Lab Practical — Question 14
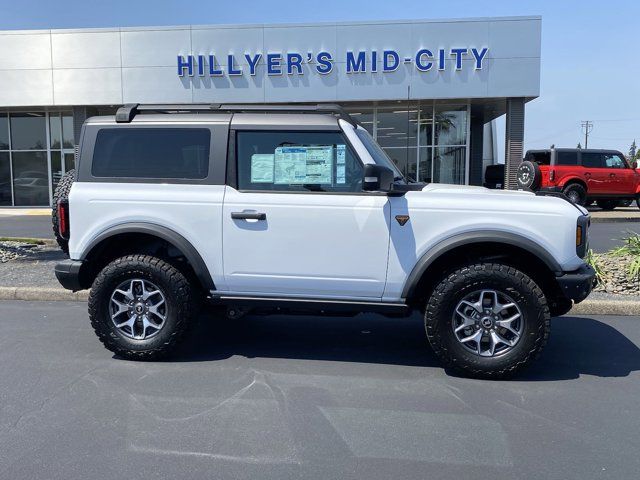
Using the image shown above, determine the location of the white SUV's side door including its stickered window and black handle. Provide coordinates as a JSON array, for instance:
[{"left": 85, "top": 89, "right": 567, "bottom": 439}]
[{"left": 223, "top": 131, "right": 390, "bottom": 299}]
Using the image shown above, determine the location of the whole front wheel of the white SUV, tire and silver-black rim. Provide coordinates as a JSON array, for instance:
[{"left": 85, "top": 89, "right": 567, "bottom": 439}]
[{"left": 424, "top": 263, "right": 551, "bottom": 378}]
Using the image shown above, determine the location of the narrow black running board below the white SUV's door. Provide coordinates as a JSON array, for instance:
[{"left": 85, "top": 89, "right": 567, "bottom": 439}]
[{"left": 211, "top": 292, "right": 411, "bottom": 315}]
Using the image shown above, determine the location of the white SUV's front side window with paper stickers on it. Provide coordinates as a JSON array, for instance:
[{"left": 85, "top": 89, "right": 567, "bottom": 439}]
[{"left": 236, "top": 131, "right": 363, "bottom": 192}]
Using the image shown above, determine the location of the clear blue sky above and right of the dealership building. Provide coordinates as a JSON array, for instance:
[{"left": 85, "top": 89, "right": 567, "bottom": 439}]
[{"left": 0, "top": 0, "right": 640, "bottom": 159}]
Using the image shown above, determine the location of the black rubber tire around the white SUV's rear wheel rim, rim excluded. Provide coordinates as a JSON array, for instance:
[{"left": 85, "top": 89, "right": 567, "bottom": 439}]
[{"left": 89, "top": 255, "right": 198, "bottom": 360}]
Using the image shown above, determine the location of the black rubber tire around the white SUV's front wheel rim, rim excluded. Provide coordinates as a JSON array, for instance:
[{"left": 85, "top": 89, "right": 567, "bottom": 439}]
[{"left": 424, "top": 263, "right": 551, "bottom": 379}]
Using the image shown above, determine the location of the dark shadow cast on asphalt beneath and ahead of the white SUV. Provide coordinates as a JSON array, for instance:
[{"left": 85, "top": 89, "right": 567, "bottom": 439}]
[{"left": 170, "top": 314, "right": 640, "bottom": 381}]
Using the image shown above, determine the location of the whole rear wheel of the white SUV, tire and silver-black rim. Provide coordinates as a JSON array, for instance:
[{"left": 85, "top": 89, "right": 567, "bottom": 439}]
[{"left": 89, "top": 255, "right": 197, "bottom": 360}]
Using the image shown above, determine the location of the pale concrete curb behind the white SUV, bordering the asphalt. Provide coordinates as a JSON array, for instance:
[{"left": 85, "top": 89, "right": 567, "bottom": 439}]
[{"left": 0, "top": 287, "right": 640, "bottom": 317}]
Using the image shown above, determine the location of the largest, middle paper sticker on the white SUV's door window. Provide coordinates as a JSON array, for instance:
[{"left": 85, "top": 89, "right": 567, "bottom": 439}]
[{"left": 274, "top": 145, "right": 333, "bottom": 185}]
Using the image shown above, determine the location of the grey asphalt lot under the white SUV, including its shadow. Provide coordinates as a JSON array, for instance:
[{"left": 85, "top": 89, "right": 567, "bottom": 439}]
[{"left": 0, "top": 301, "right": 640, "bottom": 480}]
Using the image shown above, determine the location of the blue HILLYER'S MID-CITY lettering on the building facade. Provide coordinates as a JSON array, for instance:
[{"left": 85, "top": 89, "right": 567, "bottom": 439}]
[{"left": 178, "top": 47, "right": 489, "bottom": 77}]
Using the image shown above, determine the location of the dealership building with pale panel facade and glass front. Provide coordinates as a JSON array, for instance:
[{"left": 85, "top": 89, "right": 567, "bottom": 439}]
[{"left": 0, "top": 17, "right": 541, "bottom": 207}]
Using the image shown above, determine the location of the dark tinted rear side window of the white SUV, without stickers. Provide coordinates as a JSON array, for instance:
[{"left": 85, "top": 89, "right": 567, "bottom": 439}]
[{"left": 91, "top": 128, "right": 211, "bottom": 179}]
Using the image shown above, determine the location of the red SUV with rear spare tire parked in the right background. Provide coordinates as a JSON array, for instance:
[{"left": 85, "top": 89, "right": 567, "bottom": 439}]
[{"left": 518, "top": 148, "right": 640, "bottom": 210}]
